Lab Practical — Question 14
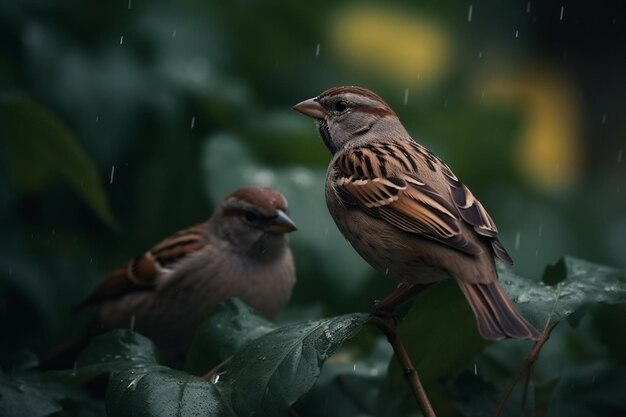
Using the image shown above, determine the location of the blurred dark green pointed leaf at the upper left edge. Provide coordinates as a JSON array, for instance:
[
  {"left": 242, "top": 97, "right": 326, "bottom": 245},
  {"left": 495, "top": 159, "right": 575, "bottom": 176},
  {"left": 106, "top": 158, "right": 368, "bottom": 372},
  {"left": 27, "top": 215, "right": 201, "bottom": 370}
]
[{"left": 0, "top": 96, "right": 118, "bottom": 230}]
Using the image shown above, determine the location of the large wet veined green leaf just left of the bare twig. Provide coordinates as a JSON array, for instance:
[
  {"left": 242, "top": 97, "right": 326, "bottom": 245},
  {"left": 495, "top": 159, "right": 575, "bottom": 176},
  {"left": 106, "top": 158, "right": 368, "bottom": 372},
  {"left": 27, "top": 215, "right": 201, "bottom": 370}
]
[{"left": 226, "top": 313, "right": 368, "bottom": 417}]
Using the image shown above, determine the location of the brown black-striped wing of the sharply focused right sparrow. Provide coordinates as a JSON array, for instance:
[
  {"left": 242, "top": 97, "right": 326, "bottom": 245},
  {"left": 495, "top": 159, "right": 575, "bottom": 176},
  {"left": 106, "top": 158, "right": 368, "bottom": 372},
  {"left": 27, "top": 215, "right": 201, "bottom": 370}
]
[{"left": 334, "top": 140, "right": 511, "bottom": 263}]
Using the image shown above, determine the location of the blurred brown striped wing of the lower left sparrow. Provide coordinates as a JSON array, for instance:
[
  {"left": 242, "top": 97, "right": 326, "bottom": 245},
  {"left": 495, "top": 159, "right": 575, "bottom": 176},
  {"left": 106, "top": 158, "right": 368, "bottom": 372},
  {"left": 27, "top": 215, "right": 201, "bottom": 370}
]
[{"left": 88, "top": 224, "right": 209, "bottom": 302}]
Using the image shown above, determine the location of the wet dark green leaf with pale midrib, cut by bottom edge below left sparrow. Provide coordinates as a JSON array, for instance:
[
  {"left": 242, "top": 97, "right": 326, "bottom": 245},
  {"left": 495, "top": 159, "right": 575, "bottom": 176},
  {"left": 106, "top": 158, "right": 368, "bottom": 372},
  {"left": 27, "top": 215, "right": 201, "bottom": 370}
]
[{"left": 106, "top": 365, "right": 233, "bottom": 417}]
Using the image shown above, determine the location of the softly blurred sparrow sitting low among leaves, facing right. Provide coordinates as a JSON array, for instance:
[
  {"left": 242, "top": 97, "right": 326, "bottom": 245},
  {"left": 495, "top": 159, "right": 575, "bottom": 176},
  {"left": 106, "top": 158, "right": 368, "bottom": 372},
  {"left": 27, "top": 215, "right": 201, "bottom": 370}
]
[{"left": 86, "top": 187, "right": 296, "bottom": 352}]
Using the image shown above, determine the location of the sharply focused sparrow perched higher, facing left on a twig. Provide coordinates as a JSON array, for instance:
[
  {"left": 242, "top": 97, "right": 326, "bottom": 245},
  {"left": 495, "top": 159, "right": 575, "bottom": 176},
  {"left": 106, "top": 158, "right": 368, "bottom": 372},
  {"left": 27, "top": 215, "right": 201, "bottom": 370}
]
[{"left": 294, "top": 87, "right": 539, "bottom": 340}]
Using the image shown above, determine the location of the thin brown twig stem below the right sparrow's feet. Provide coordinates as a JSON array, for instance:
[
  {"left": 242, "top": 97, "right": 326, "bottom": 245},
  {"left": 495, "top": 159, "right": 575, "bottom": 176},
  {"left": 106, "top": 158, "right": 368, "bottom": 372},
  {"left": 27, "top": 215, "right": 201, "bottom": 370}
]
[{"left": 370, "top": 310, "right": 437, "bottom": 417}]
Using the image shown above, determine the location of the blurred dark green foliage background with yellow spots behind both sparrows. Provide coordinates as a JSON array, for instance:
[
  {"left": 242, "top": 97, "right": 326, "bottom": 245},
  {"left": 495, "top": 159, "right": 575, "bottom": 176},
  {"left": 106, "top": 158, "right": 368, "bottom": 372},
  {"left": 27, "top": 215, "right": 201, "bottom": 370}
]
[{"left": 0, "top": 0, "right": 626, "bottom": 415}]
